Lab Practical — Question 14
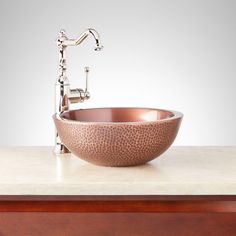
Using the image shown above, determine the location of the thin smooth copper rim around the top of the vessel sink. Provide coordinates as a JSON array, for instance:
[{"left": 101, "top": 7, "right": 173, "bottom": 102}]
[{"left": 53, "top": 107, "right": 183, "bottom": 125}]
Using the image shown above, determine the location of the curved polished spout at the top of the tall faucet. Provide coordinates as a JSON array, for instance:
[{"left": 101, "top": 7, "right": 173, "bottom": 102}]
[{"left": 61, "top": 28, "right": 103, "bottom": 51}]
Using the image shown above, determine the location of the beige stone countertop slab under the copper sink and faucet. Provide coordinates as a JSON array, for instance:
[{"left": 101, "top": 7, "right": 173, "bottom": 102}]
[{"left": 0, "top": 147, "right": 236, "bottom": 195}]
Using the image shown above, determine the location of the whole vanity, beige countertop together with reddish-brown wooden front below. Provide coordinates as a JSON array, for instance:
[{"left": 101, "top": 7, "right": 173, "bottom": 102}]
[{"left": 0, "top": 147, "right": 236, "bottom": 236}]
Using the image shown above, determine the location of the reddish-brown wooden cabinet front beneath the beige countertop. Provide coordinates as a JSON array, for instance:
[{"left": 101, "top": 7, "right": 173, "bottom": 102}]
[{"left": 0, "top": 195, "right": 236, "bottom": 236}]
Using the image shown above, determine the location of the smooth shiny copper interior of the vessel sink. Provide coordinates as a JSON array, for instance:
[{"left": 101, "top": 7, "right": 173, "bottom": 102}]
[{"left": 61, "top": 108, "right": 174, "bottom": 122}]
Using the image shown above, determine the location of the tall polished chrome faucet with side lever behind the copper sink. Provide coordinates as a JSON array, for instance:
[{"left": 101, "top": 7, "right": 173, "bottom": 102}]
[{"left": 54, "top": 29, "right": 103, "bottom": 154}]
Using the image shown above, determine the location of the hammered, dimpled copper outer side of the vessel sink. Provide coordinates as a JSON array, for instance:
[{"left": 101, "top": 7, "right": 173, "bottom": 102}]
[{"left": 53, "top": 115, "right": 182, "bottom": 166}]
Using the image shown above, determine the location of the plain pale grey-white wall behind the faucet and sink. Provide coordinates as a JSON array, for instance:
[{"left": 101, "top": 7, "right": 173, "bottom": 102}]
[{"left": 0, "top": 0, "right": 236, "bottom": 145}]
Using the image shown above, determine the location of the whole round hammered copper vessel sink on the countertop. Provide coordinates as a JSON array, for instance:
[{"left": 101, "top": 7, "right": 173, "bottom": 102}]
[{"left": 53, "top": 108, "right": 183, "bottom": 166}]
